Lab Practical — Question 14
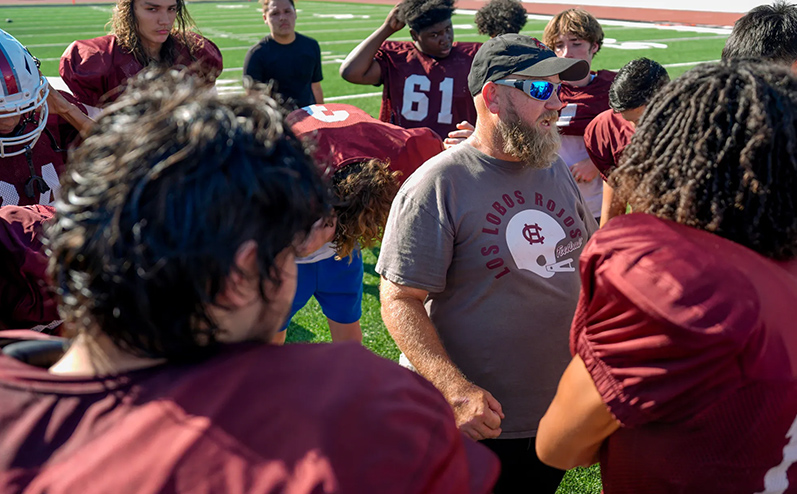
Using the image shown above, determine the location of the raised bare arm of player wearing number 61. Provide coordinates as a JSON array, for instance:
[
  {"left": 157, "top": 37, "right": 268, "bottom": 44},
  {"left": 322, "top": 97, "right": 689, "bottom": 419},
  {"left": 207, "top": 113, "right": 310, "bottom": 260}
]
[{"left": 340, "top": 6, "right": 404, "bottom": 86}]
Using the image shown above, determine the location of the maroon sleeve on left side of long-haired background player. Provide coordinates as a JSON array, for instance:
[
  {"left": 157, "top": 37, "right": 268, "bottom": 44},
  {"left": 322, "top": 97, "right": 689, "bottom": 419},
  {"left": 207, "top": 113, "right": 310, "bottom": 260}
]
[{"left": 58, "top": 36, "right": 116, "bottom": 107}]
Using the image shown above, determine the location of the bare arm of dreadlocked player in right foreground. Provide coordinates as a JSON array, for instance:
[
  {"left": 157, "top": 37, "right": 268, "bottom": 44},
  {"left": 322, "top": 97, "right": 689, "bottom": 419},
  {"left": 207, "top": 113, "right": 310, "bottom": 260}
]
[{"left": 536, "top": 356, "right": 620, "bottom": 470}]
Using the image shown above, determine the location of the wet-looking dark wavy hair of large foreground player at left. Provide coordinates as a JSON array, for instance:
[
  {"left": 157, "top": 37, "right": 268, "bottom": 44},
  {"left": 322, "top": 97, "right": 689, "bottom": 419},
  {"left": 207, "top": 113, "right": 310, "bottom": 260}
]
[{"left": 48, "top": 71, "right": 328, "bottom": 361}]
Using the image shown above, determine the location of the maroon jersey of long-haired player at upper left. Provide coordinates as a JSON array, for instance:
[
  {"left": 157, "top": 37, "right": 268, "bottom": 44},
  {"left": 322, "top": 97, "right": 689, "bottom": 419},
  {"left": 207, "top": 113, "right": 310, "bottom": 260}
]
[{"left": 59, "top": 33, "right": 222, "bottom": 107}]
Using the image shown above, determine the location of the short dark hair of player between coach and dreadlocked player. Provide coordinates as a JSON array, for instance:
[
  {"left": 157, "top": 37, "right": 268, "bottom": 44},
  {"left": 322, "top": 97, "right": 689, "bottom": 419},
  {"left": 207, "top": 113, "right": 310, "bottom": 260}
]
[{"left": 609, "top": 58, "right": 670, "bottom": 113}]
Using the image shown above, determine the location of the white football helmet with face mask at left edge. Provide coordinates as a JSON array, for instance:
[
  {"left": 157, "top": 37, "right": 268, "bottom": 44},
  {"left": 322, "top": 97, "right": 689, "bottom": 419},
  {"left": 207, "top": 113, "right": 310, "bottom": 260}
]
[{"left": 0, "top": 29, "right": 50, "bottom": 158}]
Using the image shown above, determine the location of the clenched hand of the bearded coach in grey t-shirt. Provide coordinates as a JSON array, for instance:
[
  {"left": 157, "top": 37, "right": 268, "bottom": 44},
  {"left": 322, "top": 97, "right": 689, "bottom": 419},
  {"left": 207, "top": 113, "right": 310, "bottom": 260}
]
[{"left": 447, "top": 383, "right": 504, "bottom": 441}]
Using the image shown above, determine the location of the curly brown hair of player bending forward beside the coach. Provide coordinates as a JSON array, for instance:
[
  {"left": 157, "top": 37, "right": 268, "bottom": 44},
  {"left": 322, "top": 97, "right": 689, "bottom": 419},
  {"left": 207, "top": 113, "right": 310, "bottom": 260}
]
[{"left": 332, "top": 159, "right": 399, "bottom": 259}]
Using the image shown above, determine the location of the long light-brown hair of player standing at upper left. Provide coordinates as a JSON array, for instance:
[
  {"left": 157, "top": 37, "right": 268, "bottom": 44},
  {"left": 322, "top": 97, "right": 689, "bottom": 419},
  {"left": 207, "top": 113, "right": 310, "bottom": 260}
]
[{"left": 113, "top": 0, "right": 204, "bottom": 67}]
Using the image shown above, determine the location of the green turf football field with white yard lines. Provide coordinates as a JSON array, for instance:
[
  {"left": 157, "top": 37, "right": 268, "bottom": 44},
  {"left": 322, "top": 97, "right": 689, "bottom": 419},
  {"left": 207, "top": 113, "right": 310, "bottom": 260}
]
[{"left": 0, "top": 0, "right": 729, "bottom": 494}]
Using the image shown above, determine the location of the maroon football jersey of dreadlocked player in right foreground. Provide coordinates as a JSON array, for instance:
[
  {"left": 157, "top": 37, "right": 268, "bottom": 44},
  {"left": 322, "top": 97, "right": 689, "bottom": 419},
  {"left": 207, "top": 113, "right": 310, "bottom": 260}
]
[{"left": 570, "top": 214, "right": 797, "bottom": 494}]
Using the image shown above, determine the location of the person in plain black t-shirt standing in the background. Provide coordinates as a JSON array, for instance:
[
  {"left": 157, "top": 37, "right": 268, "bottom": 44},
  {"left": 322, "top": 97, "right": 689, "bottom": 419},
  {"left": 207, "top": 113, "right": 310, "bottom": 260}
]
[{"left": 244, "top": 0, "right": 324, "bottom": 108}]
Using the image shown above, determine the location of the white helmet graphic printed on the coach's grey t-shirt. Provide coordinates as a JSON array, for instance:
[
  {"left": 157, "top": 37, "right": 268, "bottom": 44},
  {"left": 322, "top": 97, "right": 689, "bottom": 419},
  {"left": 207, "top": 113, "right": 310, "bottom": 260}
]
[{"left": 506, "top": 209, "right": 576, "bottom": 278}]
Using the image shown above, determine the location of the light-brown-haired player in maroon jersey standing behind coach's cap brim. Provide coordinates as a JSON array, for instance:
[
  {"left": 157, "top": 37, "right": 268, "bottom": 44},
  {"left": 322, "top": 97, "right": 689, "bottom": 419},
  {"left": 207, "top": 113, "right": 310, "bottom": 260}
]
[{"left": 542, "top": 9, "right": 615, "bottom": 223}]
